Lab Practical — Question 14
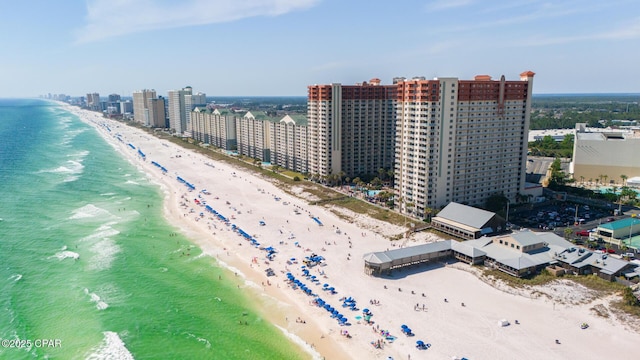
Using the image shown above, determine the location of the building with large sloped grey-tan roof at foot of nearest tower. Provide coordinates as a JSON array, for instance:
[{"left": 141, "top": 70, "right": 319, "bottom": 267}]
[{"left": 431, "top": 202, "right": 506, "bottom": 240}]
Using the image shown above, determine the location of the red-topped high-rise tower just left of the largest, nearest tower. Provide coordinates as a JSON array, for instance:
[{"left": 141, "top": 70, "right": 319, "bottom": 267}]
[{"left": 307, "top": 79, "right": 396, "bottom": 178}]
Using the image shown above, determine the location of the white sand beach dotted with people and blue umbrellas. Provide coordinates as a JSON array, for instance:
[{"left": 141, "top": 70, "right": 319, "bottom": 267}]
[{"left": 68, "top": 107, "right": 640, "bottom": 360}]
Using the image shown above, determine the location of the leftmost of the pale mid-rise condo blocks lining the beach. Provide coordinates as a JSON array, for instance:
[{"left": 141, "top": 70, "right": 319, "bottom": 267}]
[{"left": 190, "top": 107, "right": 237, "bottom": 151}]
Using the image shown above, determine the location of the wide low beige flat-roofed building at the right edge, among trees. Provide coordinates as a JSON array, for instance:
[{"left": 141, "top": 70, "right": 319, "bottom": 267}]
[{"left": 569, "top": 123, "right": 640, "bottom": 186}]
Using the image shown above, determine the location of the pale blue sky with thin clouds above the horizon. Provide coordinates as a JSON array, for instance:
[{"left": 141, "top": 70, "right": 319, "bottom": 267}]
[{"left": 0, "top": 0, "right": 640, "bottom": 97}]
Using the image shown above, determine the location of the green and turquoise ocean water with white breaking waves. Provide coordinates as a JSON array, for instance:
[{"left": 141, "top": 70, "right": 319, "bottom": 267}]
[{"left": 0, "top": 99, "right": 310, "bottom": 359}]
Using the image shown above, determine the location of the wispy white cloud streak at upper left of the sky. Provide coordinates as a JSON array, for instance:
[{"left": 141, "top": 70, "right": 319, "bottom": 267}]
[{"left": 76, "top": 0, "right": 320, "bottom": 43}]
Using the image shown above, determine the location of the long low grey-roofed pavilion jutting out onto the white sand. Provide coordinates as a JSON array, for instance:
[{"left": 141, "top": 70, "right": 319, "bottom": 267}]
[{"left": 363, "top": 240, "right": 452, "bottom": 275}]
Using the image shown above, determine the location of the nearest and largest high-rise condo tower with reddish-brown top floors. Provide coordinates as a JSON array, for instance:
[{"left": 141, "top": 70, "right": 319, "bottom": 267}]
[{"left": 394, "top": 71, "right": 535, "bottom": 217}]
